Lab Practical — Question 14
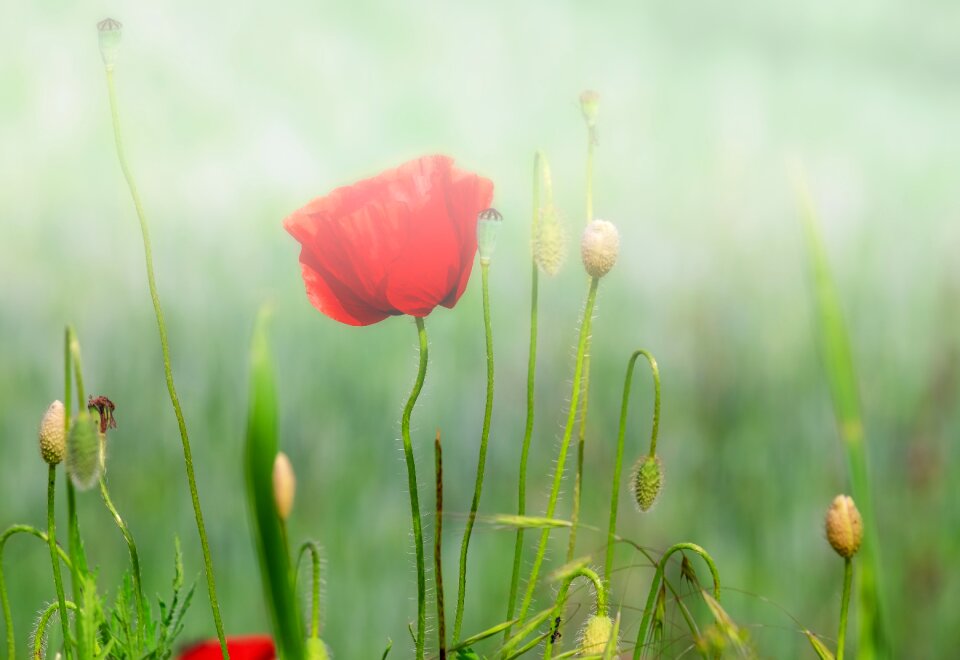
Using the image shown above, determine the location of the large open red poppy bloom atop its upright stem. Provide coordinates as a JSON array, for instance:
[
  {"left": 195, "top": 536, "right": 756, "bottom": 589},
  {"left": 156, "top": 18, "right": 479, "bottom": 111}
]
[{"left": 283, "top": 156, "right": 493, "bottom": 325}]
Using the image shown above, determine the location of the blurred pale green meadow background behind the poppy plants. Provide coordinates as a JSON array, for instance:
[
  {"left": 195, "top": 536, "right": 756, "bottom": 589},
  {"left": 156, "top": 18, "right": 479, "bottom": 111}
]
[{"left": 0, "top": 0, "right": 960, "bottom": 658}]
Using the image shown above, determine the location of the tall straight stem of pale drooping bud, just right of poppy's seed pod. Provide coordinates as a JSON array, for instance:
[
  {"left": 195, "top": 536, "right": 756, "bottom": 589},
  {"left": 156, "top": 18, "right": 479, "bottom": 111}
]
[{"left": 503, "top": 151, "right": 543, "bottom": 642}]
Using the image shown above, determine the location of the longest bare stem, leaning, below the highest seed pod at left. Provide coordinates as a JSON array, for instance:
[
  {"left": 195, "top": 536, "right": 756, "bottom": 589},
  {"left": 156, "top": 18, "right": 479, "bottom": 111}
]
[{"left": 106, "top": 68, "right": 230, "bottom": 658}]
